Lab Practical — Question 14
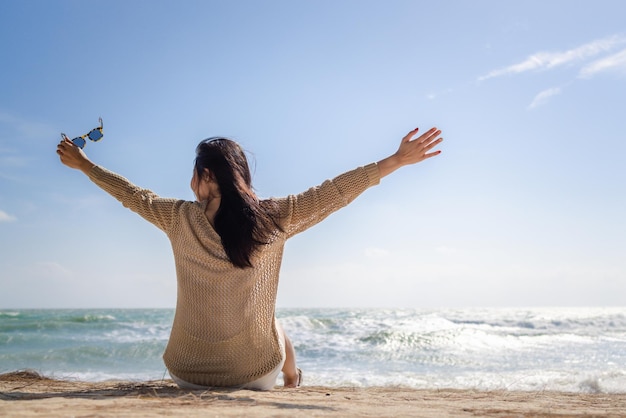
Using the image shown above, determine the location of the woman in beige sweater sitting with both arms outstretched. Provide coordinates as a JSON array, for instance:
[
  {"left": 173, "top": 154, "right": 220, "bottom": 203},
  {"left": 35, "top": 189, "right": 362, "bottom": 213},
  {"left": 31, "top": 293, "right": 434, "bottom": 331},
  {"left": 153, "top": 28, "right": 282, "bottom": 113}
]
[{"left": 57, "top": 124, "right": 442, "bottom": 390}]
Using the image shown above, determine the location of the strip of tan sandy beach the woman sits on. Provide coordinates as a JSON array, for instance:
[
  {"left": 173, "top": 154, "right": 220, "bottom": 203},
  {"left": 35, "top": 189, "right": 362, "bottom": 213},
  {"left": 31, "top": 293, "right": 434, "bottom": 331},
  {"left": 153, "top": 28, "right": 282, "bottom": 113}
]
[{"left": 0, "top": 372, "right": 626, "bottom": 417}]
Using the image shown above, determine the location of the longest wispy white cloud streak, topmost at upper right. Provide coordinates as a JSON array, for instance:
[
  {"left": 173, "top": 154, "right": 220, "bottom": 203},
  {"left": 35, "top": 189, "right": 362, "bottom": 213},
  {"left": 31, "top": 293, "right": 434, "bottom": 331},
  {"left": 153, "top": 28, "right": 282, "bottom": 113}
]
[{"left": 478, "top": 35, "right": 626, "bottom": 81}]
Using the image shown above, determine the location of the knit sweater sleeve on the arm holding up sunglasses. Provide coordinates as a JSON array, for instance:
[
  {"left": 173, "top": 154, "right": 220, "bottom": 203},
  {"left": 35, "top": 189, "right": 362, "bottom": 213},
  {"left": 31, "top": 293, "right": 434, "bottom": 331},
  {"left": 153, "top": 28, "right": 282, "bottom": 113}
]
[{"left": 89, "top": 166, "right": 182, "bottom": 233}]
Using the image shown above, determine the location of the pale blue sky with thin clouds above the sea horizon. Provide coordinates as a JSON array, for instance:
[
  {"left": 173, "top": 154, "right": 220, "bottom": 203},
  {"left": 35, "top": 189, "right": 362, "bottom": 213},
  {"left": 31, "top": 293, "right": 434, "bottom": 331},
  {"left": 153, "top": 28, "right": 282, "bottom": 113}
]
[{"left": 0, "top": 0, "right": 626, "bottom": 308}]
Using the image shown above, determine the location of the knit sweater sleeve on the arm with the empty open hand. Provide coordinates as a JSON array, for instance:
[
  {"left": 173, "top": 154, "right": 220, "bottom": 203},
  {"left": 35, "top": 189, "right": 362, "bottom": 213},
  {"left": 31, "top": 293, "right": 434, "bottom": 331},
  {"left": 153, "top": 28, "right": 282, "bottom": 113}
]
[{"left": 279, "top": 163, "right": 380, "bottom": 237}]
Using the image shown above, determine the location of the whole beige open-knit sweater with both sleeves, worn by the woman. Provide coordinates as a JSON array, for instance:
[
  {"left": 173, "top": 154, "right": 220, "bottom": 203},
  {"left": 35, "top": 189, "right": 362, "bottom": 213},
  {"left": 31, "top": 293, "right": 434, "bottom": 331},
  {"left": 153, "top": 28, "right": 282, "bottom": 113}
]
[{"left": 89, "top": 164, "right": 380, "bottom": 387}]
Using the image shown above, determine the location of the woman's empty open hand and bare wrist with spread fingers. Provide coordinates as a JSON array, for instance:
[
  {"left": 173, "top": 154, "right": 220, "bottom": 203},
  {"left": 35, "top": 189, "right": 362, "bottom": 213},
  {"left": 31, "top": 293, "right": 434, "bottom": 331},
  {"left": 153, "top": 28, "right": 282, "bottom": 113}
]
[{"left": 378, "top": 128, "right": 443, "bottom": 178}]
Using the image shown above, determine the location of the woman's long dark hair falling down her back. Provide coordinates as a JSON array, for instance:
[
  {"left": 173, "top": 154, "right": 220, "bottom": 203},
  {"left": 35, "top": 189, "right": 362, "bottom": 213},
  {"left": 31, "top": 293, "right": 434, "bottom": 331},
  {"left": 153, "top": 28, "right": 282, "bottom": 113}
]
[{"left": 195, "top": 137, "right": 280, "bottom": 268}]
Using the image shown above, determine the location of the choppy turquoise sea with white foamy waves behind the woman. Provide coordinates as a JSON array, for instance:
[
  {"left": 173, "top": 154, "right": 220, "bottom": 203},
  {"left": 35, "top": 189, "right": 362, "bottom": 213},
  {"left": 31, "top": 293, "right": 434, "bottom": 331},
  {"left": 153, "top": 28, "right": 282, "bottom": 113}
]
[{"left": 0, "top": 308, "right": 626, "bottom": 393}]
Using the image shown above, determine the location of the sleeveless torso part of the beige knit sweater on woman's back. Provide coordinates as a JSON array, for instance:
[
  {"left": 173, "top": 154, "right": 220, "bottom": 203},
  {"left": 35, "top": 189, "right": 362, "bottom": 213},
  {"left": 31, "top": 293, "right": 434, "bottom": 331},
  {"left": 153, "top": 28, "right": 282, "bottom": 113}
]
[{"left": 163, "top": 196, "right": 284, "bottom": 386}]
